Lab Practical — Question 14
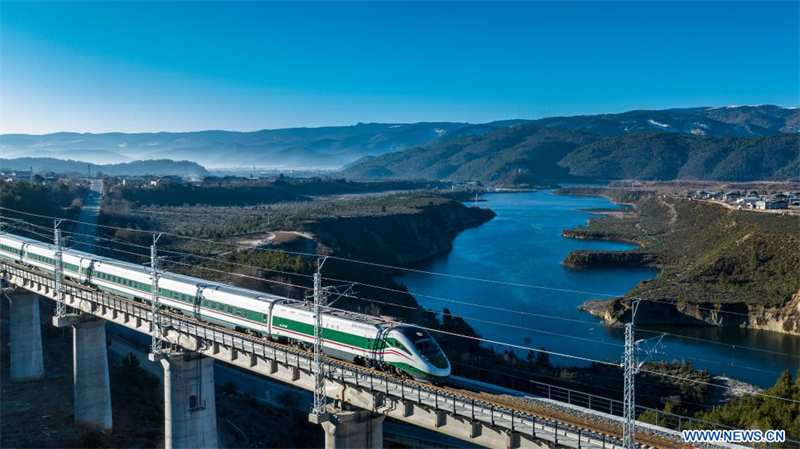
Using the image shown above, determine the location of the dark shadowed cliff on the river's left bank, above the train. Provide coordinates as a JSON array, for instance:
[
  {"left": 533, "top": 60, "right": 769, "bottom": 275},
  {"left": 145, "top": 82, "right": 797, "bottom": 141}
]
[{"left": 304, "top": 201, "right": 496, "bottom": 266}]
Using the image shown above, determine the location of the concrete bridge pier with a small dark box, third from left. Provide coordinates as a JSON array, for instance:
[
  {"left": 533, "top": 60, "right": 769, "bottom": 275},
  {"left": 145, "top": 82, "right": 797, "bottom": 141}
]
[{"left": 161, "top": 352, "right": 219, "bottom": 449}]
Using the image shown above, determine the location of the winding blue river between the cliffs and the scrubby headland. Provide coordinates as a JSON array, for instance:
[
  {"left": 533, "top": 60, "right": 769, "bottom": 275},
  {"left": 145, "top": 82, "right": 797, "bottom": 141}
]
[{"left": 398, "top": 191, "right": 800, "bottom": 387}]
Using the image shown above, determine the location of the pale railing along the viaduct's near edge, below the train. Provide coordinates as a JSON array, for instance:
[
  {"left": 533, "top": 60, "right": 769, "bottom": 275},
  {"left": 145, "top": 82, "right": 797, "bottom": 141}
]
[{"left": 0, "top": 261, "right": 621, "bottom": 447}]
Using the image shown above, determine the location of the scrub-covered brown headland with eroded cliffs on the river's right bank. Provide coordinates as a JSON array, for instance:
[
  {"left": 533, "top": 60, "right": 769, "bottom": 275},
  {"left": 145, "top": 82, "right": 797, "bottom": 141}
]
[{"left": 563, "top": 190, "right": 800, "bottom": 335}]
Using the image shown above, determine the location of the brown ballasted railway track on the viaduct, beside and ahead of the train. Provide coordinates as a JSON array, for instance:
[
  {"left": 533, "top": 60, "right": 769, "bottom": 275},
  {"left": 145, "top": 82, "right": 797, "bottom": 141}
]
[{"left": 18, "top": 262, "right": 689, "bottom": 449}]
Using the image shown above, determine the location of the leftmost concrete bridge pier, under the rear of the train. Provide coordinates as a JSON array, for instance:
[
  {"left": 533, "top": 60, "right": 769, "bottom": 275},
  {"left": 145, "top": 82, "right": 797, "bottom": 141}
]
[{"left": 8, "top": 292, "right": 44, "bottom": 382}]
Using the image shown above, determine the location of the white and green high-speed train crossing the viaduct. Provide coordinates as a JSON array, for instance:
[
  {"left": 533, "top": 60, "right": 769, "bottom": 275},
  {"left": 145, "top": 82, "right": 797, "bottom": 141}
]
[{"left": 0, "top": 233, "right": 450, "bottom": 382}]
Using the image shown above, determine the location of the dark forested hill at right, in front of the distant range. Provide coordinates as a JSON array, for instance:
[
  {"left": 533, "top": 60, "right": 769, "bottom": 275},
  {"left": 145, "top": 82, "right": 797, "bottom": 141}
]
[{"left": 342, "top": 125, "right": 800, "bottom": 185}]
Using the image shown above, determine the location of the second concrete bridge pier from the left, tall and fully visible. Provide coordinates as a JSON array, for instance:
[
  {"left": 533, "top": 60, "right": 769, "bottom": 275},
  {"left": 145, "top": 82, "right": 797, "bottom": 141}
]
[{"left": 69, "top": 315, "right": 112, "bottom": 433}]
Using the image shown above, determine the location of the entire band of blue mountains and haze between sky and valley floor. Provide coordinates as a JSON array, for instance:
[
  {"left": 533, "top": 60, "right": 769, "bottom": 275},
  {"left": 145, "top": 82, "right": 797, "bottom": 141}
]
[{"left": 0, "top": 105, "right": 800, "bottom": 178}]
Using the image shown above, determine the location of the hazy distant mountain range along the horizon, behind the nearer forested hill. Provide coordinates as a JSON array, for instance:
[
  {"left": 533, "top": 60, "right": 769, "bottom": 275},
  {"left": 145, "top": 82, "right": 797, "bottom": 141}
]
[{"left": 0, "top": 105, "right": 800, "bottom": 168}]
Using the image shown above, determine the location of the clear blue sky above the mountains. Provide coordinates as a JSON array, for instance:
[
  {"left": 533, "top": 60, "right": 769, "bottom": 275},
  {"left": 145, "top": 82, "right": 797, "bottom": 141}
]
[{"left": 0, "top": 1, "right": 800, "bottom": 134}]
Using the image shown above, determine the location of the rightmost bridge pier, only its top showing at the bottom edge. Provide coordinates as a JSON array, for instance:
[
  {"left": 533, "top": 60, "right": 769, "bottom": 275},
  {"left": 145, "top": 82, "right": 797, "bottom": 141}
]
[{"left": 309, "top": 410, "right": 385, "bottom": 449}]
